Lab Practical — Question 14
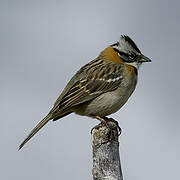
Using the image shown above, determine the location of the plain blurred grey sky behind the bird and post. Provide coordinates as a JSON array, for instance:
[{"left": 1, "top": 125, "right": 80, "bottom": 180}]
[{"left": 0, "top": 0, "right": 180, "bottom": 180}]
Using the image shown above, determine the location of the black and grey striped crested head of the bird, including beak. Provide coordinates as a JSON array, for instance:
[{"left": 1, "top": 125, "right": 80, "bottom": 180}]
[{"left": 111, "top": 35, "right": 151, "bottom": 69}]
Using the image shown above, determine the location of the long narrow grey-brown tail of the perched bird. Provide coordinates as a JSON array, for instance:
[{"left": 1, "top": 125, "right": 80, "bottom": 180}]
[{"left": 19, "top": 114, "right": 52, "bottom": 150}]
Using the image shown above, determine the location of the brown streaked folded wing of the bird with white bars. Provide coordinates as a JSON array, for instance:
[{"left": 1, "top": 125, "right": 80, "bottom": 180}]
[{"left": 51, "top": 59, "right": 124, "bottom": 113}]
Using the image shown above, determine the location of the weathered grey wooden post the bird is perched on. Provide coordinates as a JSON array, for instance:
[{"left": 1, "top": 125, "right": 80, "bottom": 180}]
[{"left": 91, "top": 119, "right": 123, "bottom": 180}]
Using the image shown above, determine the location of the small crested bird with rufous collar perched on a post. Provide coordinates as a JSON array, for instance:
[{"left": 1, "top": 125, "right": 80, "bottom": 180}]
[{"left": 19, "top": 35, "right": 151, "bottom": 150}]
